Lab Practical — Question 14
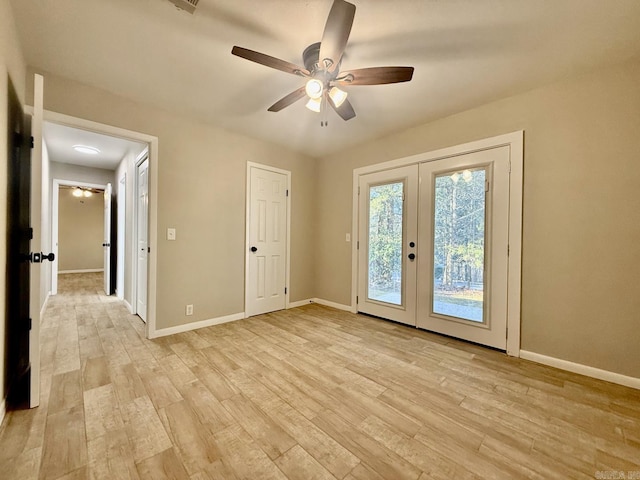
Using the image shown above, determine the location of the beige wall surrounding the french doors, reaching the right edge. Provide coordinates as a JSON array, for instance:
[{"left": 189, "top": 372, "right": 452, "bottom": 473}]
[{"left": 316, "top": 59, "right": 640, "bottom": 377}]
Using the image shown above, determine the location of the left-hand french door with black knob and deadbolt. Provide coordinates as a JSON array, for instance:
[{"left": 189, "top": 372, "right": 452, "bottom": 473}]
[{"left": 357, "top": 165, "right": 418, "bottom": 325}]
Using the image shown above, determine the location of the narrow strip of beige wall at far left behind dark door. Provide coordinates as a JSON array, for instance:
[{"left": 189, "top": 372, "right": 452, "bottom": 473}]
[{"left": 0, "top": 0, "right": 26, "bottom": 404}]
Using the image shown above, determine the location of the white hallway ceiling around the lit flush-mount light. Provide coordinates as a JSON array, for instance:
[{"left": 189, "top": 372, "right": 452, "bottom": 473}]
[{"left": 42, "top": 122, "right": 147, "bottom": 170}]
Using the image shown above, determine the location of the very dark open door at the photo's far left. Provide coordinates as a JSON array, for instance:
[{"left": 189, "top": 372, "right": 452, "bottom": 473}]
[{"left": 4, "top": 78, "right": 33, "bottom": 407}]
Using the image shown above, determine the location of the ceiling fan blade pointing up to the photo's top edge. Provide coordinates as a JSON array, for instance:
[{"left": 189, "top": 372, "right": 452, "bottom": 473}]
[{"left": 319, "top": 0, "right": 356, "bottom": 72}]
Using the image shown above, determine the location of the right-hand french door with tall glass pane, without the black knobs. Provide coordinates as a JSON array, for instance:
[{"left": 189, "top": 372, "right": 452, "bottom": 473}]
[{"left": 417, "top": 146, "right": 509, "bottom": 350}]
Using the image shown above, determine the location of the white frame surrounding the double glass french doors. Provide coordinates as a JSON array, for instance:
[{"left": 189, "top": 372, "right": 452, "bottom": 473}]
[{"left": 351, "top": 130, "right": 524, "bottom": 357}]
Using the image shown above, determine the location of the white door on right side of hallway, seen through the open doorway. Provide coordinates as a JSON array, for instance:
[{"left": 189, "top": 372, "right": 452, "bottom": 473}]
[{"left": 136, "top": 159, "right": 149, "bottom": 322}]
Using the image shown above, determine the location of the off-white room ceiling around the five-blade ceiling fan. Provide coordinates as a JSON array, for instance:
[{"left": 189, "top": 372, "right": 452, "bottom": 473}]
[{"left": 11, "top": 0, "right": 640, "bottom": 157}]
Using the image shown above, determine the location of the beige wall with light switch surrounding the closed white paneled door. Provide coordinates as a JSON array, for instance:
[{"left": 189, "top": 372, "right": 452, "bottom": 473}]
[{"left": 33, "top": 73, "right": 316, "bottom": 329}]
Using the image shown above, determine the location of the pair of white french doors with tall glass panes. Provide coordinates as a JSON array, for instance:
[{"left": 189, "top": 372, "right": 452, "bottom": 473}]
[{"left": 357, "top": 146, "right": 509, "bottom": 350}]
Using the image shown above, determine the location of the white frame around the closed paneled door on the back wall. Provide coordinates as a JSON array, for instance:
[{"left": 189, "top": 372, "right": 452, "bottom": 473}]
[{"left": 244, "top": 162, "right": 292, "bottom": 318}]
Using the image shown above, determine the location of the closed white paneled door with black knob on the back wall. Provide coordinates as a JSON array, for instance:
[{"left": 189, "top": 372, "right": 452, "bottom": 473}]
[{"left": 245, "top": 166, "right": 288, "bottom": 316}]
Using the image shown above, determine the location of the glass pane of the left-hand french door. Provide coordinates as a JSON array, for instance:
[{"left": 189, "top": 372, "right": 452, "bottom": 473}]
[{"left": 367, "top": 182, "right": 404, "bottom": 305}]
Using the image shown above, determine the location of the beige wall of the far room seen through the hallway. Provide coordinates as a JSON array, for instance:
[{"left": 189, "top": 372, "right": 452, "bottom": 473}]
[{"left": 58, "top": 188, "right": 104, "bottom": 272}]
